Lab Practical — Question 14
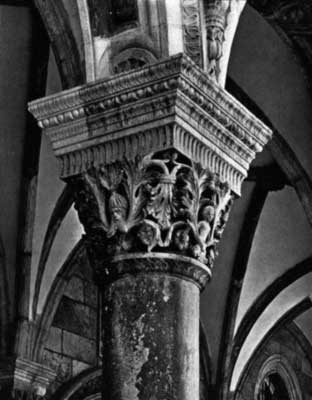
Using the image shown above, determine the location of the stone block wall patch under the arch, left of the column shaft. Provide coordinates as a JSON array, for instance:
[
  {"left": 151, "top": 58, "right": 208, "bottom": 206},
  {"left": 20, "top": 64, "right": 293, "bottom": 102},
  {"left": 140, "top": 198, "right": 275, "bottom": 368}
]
[{"left": 43, "top": 265, "right": 99, "bottom": 387}]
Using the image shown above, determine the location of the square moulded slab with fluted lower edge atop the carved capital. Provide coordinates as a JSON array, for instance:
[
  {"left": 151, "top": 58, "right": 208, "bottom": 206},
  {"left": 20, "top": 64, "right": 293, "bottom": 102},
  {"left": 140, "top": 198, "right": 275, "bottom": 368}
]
[{"left": 30, "top": 55, "right": 271, "bottom": 194}]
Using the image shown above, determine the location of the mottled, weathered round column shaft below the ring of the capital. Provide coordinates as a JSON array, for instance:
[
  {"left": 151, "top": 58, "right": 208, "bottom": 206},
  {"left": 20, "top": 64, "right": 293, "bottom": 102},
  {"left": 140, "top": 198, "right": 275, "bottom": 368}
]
[{"left": 103, "top": 273, "right": 199, "bottom": 400}]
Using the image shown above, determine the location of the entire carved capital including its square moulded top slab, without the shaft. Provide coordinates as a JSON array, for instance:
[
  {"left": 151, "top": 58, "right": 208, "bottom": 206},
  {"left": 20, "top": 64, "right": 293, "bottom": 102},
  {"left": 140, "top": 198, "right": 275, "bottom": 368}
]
[{"left": 30, "top": 55, "right": 271, "bottom": 284}]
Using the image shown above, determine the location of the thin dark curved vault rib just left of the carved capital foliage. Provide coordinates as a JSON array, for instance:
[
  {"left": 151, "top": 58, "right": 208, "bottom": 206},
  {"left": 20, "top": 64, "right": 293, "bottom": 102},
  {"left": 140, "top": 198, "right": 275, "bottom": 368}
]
[{"left": 32, "top": 185, "right": 74, "bottom": 317}]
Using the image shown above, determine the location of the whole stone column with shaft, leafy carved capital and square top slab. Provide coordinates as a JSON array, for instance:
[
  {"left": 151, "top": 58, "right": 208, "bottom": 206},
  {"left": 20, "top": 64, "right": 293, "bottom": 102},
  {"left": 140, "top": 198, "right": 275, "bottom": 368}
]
[{"left": 30, "top": 55, "right": 271, "bottom": 400}]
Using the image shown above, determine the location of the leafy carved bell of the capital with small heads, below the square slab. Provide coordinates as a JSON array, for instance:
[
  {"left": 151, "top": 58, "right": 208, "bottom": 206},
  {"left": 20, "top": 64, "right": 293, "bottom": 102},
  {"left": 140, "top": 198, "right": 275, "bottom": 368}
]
[{"left": 72, "top": 151, "right": 233, "bottom": 268}]
